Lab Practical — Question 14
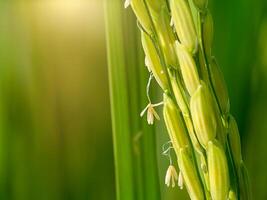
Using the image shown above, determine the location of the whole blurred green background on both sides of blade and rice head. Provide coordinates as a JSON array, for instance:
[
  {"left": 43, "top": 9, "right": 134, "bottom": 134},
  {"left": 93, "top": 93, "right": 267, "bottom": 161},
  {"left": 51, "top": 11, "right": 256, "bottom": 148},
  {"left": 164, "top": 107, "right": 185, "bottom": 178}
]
[{"left": 0, "top": 0, "right": 267, "bottom": 200}]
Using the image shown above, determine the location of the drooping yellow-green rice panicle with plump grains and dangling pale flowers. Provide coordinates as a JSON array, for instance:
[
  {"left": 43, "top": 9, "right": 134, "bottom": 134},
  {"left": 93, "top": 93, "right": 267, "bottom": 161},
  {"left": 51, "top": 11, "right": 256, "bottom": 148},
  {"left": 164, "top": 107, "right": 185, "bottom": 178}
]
[{"left": 125, "top": 0, "right": 250, "bottom": 200}]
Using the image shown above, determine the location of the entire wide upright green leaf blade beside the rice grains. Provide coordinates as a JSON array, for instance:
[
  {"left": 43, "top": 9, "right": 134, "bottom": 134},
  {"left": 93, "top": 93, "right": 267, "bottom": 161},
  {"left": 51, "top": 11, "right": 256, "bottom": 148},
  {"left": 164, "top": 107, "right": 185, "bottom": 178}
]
[{"left": 105, "top": 0, "right": 160, "bottom": 200}]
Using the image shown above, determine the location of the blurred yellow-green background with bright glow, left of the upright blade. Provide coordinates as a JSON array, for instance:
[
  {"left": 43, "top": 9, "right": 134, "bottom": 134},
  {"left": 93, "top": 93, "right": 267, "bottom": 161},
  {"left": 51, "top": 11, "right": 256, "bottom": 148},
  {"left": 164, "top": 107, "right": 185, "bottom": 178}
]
[{"left": 0, "top": 0, "right": 115, "bottom": 200}]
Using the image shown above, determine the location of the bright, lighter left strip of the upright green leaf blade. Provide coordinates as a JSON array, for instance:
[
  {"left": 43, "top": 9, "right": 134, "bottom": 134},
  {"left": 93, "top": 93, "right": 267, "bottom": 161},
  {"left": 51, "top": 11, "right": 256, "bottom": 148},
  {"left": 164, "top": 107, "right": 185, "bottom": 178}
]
[{"left": 105, "top": 0, "right": 135, "bottom": 200}]
